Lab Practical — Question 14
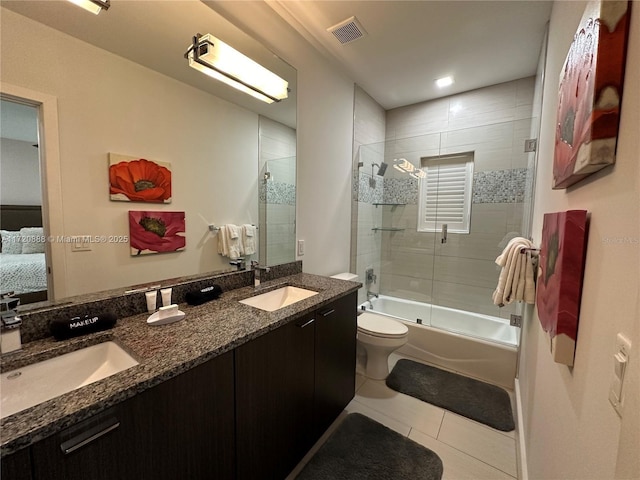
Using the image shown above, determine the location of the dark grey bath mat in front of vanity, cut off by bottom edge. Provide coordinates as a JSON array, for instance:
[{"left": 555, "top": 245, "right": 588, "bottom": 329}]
[{"left": 296, "top": 413, "right": 443, "bottom": 480}]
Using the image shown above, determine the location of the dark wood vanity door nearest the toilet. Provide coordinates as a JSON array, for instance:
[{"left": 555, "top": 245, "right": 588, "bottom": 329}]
[{"left": 315, "top": 293, "right": 357, "bottom": 437}]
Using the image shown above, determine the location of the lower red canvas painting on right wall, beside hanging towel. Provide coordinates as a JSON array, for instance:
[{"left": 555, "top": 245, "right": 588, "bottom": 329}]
[{"left": 536, "top": 210, "right": 587, "bottom": 365}]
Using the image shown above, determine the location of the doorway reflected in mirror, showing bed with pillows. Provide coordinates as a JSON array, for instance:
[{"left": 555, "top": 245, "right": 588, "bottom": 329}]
[{"left": 0, "top": 98, "right": 49, "bottom": 305}]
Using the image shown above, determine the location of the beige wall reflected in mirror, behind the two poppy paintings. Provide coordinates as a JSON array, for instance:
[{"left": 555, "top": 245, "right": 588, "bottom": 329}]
[{"left": 1, "top": 9, "right": 258, "bottom": 295}]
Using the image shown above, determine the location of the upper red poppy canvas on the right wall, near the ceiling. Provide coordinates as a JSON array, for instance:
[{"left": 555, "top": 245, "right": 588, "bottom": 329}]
[{"left": 553, "top": 0, "right": 631, "bottom": 189}]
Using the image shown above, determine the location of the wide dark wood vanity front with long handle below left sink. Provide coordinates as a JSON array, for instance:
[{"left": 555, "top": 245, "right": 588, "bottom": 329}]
[{"left": 31, "top": 352, "right": 235, "bottom": 480}]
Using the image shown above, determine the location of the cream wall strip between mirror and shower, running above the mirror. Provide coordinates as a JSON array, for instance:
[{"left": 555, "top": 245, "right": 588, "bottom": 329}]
[{"left": 205, "top": 0, "right": 354, "bottom": 275}]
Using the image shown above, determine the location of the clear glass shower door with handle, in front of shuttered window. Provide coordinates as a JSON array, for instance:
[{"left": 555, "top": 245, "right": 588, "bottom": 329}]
[{"left": 426, "top": 118, "right": 531, "bottom": 341}]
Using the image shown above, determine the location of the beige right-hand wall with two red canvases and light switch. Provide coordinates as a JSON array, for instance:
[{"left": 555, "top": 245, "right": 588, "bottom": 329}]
[{"left": 520, "top": 2, "right": 640, "bottom": 479}]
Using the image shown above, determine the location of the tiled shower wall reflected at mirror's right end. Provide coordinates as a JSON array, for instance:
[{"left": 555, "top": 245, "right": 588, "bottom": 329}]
[{"left": 259, "top": 116, "right": 296, "bottom": 265}]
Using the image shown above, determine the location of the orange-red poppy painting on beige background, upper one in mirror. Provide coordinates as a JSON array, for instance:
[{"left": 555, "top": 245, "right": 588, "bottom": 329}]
[{"left": 109, "top": 153, "right": 171, "bottom": 203}]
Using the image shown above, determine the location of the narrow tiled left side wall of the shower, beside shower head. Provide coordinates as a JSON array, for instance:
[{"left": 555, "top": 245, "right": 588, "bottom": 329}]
[{"left": 350, "top": 86, "right": 386, "bottom": 303}]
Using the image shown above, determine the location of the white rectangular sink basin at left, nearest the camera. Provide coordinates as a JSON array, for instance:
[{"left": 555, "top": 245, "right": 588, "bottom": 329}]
[{"left": 0, "top": 342, "right": 138, "bottom": 418}]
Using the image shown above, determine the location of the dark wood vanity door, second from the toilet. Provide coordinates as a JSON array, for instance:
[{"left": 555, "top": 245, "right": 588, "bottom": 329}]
[{"left": 235, "top": 317, "right": 315, "bottom": 480}]
